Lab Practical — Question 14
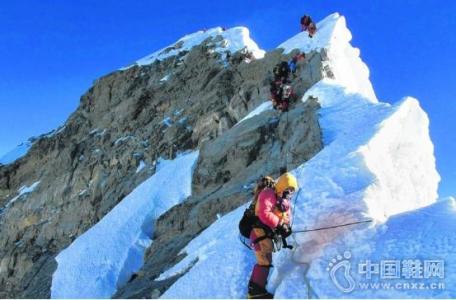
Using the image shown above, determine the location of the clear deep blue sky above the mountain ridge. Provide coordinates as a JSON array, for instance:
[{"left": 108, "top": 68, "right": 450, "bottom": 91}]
[{"left": 0, "top": 0, "right": 456, "bottom": 196}]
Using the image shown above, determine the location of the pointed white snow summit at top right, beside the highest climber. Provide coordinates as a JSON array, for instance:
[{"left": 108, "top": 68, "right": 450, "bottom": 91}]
[{"left": 277, "top": 13, "right": 377, "bottom": 102}]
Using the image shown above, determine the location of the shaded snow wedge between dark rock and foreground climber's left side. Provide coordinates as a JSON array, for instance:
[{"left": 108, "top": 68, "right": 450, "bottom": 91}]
[{"left": 158, "top": 205, "right": 255, "bottom": 299}]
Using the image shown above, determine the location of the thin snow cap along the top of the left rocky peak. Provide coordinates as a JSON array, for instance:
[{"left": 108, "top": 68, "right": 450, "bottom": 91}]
[{"left": 127, "top": 27, "right": 265, "bottom": 68}]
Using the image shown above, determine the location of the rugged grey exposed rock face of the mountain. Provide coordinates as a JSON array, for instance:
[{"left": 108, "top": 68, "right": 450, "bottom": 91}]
[{"left": 0, "top": 33, "right": 330, "bottom": 298}]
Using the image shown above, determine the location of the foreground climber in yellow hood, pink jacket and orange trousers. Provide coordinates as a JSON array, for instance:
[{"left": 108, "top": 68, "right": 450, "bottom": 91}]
[{"left": 248, "top": 173, "right": 298, "bottom": 299}]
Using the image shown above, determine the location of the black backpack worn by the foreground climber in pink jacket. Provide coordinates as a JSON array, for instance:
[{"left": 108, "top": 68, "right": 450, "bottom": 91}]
[{"left": 239, "top": 176, "right": 275, "bottom": 238}]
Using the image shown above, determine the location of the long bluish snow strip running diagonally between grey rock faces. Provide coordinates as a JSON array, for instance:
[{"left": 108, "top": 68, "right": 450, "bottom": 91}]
[{"left": 51, "top": 151, "right": 198, "bottom": 298}]
